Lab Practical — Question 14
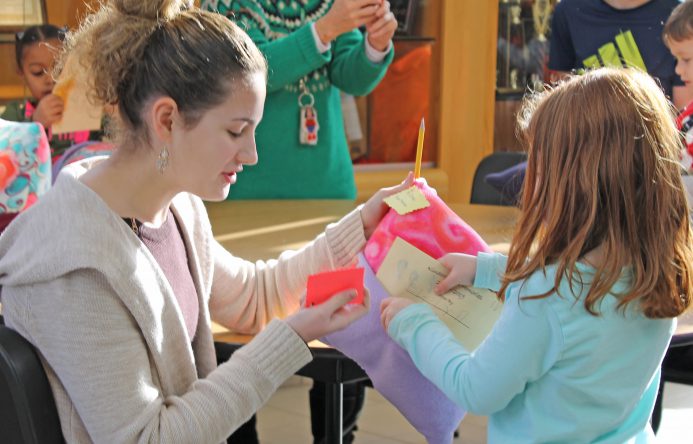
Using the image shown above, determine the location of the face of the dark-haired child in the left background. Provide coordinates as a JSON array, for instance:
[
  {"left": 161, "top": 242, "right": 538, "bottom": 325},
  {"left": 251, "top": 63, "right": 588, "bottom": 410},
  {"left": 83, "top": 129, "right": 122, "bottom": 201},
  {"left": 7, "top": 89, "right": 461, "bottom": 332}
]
[{"left": 19, "top": 39, "right": 62, "bottom": 100}]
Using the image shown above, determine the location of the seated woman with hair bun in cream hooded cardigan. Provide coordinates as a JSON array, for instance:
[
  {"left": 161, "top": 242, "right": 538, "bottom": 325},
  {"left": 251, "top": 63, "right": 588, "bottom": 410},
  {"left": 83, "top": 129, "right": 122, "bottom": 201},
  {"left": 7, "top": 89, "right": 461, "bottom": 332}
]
[{"left": 0, "top": 0, "right": 412, "bottom": 443}]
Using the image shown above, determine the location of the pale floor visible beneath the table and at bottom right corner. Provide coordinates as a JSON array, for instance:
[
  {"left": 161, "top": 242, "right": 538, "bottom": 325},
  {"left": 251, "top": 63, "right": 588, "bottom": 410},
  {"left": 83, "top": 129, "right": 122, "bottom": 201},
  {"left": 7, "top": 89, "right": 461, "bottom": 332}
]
[{"left": 258, "top": 377, "right": 693, "bottom": 444}]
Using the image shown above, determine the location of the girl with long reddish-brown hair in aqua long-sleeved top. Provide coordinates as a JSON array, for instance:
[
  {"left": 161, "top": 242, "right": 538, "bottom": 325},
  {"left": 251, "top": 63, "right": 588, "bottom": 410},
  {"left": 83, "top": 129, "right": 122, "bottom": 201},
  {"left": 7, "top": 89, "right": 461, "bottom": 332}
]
[{"left": 381, "top": 68, "right": 693, "bottom": 443}]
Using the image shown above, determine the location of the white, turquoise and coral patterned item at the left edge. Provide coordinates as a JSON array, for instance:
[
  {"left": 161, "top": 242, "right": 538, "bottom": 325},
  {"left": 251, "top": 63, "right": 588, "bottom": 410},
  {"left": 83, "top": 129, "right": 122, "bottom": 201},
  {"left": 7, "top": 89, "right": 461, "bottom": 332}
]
[{"left": 0, "top": 119, "right": 51, "bottom": 231}]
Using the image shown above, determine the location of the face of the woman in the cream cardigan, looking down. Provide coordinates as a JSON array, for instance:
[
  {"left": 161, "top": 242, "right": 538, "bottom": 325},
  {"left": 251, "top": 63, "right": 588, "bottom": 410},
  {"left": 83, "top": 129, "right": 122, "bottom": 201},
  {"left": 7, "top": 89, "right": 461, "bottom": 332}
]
[{"left": 169, "top": 73, "right": 266, "bottom": 201}]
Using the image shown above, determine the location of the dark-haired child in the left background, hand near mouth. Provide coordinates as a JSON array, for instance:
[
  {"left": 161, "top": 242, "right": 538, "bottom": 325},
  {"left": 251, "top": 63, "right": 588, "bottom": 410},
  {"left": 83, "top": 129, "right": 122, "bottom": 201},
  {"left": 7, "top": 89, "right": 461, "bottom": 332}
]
[{"left": 0, "top": 25, "right": 99, "bottom": 159}]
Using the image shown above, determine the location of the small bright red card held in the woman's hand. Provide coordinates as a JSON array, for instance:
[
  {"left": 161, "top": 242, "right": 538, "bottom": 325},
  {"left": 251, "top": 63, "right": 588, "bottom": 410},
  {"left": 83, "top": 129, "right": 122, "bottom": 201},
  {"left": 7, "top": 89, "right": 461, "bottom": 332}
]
[{"left": 306, "top": 268, "right": 363, "bottom": 307}]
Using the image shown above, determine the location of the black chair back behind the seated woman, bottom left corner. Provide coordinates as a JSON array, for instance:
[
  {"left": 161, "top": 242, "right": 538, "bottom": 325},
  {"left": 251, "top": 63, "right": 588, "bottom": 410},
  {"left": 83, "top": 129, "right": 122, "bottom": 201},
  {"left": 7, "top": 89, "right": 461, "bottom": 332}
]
[{"left": 0, "top": 319, "right": 64, "bottom": 444}]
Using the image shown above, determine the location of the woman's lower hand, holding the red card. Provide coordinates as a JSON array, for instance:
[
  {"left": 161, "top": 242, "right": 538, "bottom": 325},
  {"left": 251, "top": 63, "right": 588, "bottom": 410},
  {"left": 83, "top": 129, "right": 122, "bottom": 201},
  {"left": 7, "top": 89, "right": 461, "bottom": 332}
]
[{"left": 286, "top": 289, "right": 370, "bottom": 343}]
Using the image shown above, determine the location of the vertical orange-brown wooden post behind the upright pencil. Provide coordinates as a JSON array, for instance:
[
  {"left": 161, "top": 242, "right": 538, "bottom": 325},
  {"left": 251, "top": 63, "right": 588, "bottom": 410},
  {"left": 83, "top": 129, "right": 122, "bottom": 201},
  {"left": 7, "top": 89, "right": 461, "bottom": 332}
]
[{"left": 440, "top": 0, "right": 498, "bottom": 202}]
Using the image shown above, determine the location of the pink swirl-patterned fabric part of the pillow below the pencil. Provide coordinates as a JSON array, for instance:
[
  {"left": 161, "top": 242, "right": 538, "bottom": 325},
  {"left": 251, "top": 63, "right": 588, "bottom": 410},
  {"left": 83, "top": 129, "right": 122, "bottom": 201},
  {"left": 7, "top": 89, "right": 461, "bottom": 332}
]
[{"left": 363, "top": 181, "right": 491, "bottom": 273}]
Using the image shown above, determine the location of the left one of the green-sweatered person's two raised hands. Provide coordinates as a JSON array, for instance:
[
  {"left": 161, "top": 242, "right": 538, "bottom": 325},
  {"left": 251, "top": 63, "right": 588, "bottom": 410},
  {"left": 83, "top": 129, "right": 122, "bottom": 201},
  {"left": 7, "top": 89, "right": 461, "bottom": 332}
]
[{"left": 315, "top": 0, "right": 382, "bottom": 44}]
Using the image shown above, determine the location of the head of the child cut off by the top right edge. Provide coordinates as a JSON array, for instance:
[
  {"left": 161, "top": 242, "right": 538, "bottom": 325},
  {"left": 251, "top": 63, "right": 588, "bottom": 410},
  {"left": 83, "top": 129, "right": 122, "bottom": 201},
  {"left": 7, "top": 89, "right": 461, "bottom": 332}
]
[{"left": 662, "top": 0, "right": 693, "bottom": 84}]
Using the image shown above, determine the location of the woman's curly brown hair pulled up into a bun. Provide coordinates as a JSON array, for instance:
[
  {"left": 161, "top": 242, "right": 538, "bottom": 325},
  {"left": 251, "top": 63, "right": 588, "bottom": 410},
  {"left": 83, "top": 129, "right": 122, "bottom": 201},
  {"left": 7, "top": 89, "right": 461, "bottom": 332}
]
[{"left": 62, "top": 0, "right": 267, "bottom": 141}]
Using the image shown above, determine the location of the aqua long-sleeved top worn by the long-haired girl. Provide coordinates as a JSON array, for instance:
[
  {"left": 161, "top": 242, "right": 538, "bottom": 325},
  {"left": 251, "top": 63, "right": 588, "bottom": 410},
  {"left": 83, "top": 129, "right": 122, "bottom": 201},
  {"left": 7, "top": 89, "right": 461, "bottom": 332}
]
[{"left": 388, "top": 253, "right": 676, "bottom": 444}]
